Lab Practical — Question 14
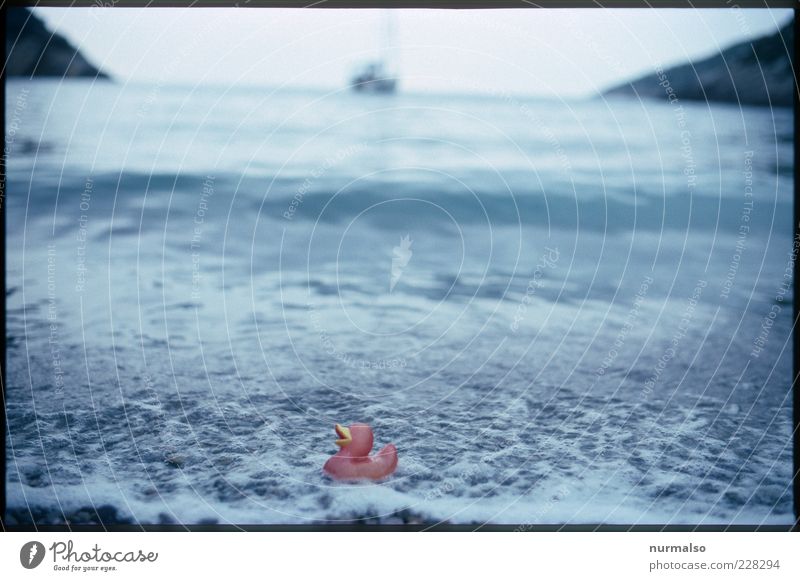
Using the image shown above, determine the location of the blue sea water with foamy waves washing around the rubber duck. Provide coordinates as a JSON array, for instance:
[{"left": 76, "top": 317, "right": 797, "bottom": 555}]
[{"left": 4, "top": 80, "right": 795, "bottom": 525}]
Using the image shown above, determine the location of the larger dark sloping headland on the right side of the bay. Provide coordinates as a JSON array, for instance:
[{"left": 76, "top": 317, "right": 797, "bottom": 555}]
[{"left": 605, "top": 21, "right": 796, "bottom": 106}]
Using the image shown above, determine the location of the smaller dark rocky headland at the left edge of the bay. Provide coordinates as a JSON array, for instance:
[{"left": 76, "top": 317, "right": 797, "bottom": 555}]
[{"left": 6, "top": 8, "right": 108, "bottom": 78}]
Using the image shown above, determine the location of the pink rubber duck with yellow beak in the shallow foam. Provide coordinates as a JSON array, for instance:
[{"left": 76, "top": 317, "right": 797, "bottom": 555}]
[{"left": 322, "top": 424, "right": 397, "bottom": 480}]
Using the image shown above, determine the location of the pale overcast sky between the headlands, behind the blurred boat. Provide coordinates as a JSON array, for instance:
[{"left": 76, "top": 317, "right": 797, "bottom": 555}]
[{"left": 35, "top": 8, "right": 791, "bottom": 96}]
